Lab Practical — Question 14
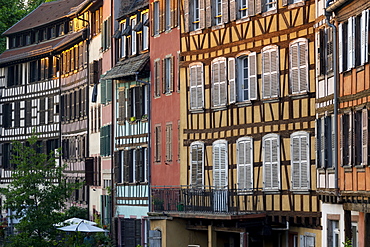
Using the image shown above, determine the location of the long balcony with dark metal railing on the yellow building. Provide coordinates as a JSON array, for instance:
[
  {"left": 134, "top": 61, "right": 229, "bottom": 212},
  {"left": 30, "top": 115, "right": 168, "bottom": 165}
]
[{"left": 151, "top": 186, "right": 321, "bottom": 225}]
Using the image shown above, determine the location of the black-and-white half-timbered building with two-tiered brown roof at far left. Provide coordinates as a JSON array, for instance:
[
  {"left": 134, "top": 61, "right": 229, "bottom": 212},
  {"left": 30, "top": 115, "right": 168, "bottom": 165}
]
[{"left": 0, "top": 0, "right": 88, "bottom": 215}]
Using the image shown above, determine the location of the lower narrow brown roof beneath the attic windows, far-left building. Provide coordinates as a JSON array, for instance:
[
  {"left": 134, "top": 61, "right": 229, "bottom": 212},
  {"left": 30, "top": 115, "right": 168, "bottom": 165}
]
[{"left": 0, "top": 30, "right": 83, "bottom": 65}]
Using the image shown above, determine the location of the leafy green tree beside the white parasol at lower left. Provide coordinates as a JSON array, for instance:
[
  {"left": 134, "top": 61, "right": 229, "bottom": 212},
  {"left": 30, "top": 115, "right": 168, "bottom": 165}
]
[{"left": 0, "top": 135, "right": 81, "bottom": 247}]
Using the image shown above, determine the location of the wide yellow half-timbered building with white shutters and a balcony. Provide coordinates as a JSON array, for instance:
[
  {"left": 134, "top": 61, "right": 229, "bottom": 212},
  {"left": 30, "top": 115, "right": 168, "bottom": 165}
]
[{"left": 151, "top": 0, "right": 321, "bottom": 246}]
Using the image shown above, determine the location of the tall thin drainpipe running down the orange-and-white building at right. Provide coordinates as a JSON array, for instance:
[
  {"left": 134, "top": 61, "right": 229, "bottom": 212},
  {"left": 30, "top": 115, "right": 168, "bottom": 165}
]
[{"left": 325, "top": 0, "right": 338, "bottom": 193}]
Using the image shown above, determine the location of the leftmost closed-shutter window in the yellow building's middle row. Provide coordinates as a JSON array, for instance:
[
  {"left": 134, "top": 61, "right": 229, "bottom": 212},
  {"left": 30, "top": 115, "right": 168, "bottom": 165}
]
[{"left": 189, "top": 63, "right": 204, "bottom": 110}]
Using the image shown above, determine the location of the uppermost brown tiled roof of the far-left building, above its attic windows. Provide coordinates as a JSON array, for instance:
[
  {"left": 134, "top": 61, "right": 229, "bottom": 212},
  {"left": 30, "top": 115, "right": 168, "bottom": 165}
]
[{"left": 3, "top": 0, "right": 90, "bottom": 35}]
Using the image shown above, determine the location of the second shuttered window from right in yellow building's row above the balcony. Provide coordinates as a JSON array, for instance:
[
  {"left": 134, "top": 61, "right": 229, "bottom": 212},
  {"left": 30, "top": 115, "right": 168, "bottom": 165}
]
[{"left": 262, "top": 134, "right": 280, "bottom": 190}]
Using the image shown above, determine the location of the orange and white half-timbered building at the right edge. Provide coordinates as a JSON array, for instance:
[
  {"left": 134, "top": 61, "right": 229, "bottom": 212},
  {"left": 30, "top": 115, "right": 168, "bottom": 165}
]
[{"left": 316, "top": 1, "right": 370, "bottom": 246}]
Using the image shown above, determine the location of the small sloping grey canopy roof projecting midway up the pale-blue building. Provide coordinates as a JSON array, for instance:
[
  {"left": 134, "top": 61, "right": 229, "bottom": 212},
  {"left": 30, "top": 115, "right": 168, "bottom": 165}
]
[{"left": 104, "top": 53, "right": 149, "bottom": 79}]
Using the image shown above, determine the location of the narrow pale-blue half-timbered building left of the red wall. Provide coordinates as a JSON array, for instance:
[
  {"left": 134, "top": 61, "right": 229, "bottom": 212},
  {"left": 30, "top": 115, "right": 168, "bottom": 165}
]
[{"left": 107, "top": 0, "right": 150, "bottom": 246}]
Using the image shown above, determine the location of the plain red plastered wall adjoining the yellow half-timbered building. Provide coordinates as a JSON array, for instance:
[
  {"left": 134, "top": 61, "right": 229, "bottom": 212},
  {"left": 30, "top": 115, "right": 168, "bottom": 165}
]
[{"left": 150, "top": 19, "right": 180, "bottom": 185}]
